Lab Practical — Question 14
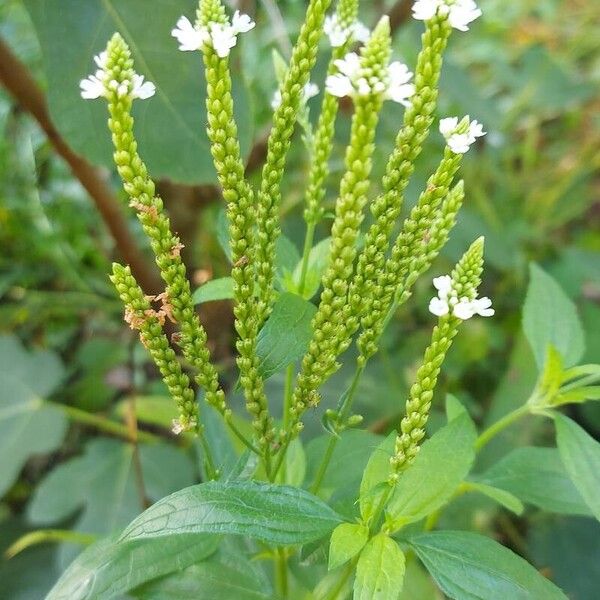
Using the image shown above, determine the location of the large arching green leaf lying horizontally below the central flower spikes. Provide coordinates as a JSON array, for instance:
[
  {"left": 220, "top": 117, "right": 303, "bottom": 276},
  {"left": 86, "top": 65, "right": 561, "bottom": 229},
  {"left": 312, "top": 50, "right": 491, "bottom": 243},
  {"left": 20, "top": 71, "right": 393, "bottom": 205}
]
[{"left": 121, "top": 480, "right": 341, "bottom": 544}]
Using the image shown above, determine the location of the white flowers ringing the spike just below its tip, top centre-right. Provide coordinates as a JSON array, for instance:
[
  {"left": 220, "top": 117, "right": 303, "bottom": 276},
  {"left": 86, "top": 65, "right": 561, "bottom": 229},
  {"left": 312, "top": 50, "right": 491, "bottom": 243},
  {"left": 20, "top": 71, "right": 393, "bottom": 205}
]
[{"left": 325, "top": 52, "right": 415, "bottom": 106}]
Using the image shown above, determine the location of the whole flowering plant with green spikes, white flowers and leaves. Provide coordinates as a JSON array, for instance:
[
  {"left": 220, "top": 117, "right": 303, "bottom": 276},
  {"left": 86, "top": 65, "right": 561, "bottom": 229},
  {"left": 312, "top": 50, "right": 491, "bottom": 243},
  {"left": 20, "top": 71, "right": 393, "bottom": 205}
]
[{"left": 34, "top": 0, "right": 599, "bottom": 600}]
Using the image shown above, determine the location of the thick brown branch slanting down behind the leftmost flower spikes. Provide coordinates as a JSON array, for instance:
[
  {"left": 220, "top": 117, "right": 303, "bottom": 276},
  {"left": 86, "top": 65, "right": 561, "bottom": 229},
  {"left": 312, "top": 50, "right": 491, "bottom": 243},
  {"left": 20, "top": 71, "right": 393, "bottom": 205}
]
[{"left": 0, "top": 39, "right": 160, "bottom": 292}]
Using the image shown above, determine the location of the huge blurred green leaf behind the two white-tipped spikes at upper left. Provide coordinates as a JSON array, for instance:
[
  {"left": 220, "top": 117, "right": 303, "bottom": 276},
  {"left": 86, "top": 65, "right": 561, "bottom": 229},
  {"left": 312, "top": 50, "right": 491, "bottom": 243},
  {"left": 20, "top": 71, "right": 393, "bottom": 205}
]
[{"left": 25, "top": 0, "right": 253, "bottom": 183}]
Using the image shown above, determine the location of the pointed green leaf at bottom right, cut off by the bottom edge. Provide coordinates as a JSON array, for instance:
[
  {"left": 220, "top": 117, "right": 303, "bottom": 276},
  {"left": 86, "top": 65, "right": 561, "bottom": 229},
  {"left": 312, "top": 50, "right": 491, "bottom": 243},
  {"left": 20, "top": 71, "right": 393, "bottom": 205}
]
[{"left": 408, "top": 531, "right": 566, "bottom": 600}]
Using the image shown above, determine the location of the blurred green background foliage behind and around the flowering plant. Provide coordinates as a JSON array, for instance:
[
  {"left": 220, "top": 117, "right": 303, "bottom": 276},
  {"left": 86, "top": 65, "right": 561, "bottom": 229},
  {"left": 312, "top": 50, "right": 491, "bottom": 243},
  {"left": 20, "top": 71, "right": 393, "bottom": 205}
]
[{"left": 0, "top": 0, "right": 600, "bottom": 600}]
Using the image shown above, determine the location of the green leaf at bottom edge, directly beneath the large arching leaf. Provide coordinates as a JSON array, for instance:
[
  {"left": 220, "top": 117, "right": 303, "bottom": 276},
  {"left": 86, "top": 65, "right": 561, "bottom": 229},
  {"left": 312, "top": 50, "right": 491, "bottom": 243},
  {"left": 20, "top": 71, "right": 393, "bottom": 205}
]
[{"left": 133, "top": 548, "right": 273, "bottom": 600}]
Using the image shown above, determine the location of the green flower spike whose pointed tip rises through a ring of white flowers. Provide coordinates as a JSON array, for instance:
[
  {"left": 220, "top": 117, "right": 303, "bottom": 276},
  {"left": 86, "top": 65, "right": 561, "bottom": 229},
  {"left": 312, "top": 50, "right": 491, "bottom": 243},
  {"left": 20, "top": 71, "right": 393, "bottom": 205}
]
[{"left": 292, "top": 18, "right": 391, "bottom": 440}]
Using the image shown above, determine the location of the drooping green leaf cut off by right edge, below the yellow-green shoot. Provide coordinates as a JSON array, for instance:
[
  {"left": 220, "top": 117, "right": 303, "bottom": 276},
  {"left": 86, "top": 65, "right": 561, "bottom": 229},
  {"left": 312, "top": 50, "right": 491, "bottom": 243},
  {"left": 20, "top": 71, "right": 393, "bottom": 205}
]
[{"left": 554, "top": 413, "right": 600, "bottom": 521}]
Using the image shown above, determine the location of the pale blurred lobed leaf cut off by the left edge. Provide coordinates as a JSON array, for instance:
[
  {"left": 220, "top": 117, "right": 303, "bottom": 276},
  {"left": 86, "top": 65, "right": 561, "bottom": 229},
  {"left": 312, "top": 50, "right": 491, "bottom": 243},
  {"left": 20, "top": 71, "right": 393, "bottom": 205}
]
[{"left": 0, "top": 336, "right": 68, "bottom": 497}]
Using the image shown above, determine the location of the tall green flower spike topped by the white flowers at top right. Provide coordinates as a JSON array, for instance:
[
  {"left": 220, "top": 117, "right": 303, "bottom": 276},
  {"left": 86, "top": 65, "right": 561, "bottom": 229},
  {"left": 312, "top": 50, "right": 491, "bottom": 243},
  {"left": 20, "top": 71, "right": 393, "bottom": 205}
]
[{"left": 350, "top": 17, "right": 452, "bottom": 340}]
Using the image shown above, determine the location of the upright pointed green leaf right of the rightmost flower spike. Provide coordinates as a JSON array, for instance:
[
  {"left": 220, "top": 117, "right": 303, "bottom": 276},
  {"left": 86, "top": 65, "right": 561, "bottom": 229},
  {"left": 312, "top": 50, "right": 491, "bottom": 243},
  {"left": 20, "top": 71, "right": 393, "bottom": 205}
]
[{"left": 523, "top": 264, "right": 585, "bottom": 371}]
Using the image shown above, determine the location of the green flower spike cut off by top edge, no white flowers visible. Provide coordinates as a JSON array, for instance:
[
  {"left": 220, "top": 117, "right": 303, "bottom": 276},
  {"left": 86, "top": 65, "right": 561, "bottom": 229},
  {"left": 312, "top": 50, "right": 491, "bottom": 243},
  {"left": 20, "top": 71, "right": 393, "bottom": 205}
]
[{"left": 256, "top": 0, "right": 331, "bottom": 324}]
